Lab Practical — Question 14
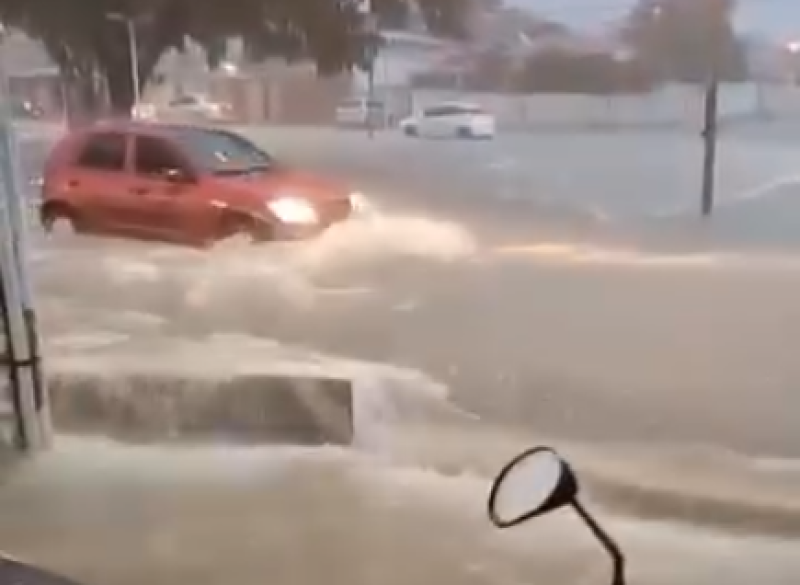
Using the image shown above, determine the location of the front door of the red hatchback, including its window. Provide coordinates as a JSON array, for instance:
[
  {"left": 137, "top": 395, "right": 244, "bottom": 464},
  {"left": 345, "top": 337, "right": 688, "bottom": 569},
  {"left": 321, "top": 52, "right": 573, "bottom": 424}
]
[{"left": 131, "top": 134, "right": 216, "bottom": 243}]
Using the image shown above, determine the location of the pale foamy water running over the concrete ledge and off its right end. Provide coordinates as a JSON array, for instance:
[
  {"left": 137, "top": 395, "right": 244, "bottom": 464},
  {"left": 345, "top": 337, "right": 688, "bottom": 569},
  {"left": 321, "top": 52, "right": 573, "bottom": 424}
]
[{"left": 48, "top": 333, "right": 474, "bottom": 454}]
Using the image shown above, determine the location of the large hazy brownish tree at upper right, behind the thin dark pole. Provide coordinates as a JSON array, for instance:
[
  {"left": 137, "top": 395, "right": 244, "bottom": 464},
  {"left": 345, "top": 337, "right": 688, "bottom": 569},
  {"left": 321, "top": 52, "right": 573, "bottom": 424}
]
[{"left": 624, "top": 0, "right": 746, "bottom": 83}]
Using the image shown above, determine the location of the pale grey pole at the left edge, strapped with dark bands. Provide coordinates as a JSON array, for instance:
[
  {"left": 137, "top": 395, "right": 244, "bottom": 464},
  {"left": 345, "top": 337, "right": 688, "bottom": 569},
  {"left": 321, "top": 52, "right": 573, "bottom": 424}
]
[{"left": 0, "top": 25, "right": 52, "bottom": 451}]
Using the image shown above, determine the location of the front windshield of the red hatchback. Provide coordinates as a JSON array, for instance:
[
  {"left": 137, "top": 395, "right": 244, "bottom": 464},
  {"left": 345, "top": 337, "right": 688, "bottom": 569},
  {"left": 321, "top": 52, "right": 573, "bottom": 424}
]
[{"left": 164, "top": 128, "right": 275, "bottom": 175}]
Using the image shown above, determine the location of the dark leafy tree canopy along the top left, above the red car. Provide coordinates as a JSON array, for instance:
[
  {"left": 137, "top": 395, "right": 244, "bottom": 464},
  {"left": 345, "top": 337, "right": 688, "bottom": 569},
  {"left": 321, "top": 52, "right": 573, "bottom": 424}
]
[{"left": 0, "top": 0, "right": 469, "bottom": 115}]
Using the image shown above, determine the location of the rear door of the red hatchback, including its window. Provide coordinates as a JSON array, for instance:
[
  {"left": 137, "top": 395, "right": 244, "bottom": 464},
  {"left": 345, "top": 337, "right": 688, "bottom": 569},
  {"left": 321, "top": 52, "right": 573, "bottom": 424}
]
[{"left": 64, "top": 131, "right": 131, "bottom": 232}]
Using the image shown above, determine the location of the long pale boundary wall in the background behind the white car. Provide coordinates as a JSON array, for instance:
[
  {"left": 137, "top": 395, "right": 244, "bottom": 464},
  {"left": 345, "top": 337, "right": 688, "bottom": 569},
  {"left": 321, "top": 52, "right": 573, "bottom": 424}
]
[{"left": 413, "top": 84, "right": 800, "bottom": 130}]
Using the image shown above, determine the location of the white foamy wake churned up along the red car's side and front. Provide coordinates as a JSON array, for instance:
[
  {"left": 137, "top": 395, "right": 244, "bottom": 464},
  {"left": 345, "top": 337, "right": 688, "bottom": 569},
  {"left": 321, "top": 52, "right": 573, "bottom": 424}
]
[{"left": 34, "top": 213, "right": 476, "bottom": 323}]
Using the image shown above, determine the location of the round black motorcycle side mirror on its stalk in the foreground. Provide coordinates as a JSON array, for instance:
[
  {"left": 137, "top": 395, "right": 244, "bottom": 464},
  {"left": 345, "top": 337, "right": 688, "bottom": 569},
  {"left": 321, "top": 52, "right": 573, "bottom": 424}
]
[{"left": 488, "top": 447, "right": 625, "bottom": 585}]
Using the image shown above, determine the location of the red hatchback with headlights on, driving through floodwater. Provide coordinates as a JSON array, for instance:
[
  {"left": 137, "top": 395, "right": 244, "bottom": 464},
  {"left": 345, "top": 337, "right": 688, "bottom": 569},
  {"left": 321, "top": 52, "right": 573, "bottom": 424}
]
[{"left": 40, "top": 121, "right": 360, "bottom": 246}]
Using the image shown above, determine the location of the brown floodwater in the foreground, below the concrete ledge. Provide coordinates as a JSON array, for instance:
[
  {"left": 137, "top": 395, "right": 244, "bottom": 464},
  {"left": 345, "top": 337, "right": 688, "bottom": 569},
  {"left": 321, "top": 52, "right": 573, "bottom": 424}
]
[{"left": 0, "top": 439, "right": 800, "bottom": 585}]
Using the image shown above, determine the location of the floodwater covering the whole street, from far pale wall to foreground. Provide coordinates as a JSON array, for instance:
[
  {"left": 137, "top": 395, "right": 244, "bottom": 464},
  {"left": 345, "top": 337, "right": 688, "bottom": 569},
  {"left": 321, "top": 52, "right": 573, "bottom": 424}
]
[{"left": 6, "top": 123, "right": 800, "bottom": 585}]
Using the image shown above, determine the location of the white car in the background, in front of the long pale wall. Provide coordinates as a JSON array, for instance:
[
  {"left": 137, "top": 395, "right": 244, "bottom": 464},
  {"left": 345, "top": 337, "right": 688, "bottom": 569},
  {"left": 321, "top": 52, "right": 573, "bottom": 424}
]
[{"left": 400, "top": 103, "right": 495, "bottom": 138}]
